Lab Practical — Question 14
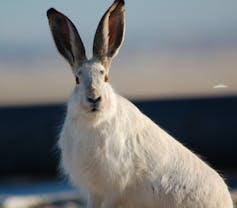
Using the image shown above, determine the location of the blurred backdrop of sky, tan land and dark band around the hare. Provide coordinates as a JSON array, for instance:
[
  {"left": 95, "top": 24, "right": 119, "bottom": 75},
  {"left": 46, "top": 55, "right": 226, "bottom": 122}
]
[{"left": 0, "top": 0, "right": 237, "bottom": 207}]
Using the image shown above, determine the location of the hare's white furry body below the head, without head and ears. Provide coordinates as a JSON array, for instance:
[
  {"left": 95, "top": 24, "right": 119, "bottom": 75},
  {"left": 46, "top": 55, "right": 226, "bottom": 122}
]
[{"left": 59, "top": 88, "right": 232, "bottom": 208}]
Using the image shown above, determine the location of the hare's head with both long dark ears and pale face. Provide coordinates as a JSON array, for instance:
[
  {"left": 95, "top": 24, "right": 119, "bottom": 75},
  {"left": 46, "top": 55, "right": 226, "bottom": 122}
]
[{"left": 47, "top": 0, "right": 125, "bottom": 117}]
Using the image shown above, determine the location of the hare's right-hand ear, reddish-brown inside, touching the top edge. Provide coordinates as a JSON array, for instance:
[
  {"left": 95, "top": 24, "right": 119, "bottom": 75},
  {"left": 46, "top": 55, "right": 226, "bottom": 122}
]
[{"left": 93, "top": 0, "right": 125, "bottom": 69}]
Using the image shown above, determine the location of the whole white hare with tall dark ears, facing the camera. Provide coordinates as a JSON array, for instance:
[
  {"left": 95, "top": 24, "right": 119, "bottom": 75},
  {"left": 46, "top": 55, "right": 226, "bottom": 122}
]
[{"left": 47, "top": 0, "right": 233, "bottom": 208}]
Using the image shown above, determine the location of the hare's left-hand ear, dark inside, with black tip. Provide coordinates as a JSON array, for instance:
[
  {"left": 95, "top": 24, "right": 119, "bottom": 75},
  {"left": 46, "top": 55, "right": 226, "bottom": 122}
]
[{"left": 47, "top": 8, "right": 86, "bottom": 73}]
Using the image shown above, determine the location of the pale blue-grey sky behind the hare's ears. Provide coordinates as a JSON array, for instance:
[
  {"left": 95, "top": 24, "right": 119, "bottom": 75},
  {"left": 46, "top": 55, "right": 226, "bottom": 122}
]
[{"left": 0, "top": 0, "right": 237, "bottom": 56}]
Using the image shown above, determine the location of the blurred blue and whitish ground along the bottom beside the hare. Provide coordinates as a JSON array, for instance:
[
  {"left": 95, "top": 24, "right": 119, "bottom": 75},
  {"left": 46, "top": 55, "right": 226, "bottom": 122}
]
[{"left": 0, "top": 174, "right": 237, "bottom": 208}]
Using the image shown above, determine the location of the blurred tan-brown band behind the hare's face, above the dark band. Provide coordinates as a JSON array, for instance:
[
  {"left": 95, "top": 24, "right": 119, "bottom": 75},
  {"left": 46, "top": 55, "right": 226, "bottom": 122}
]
[{"left": 0, "top": 48, "right": 237, "bottom": 105}]
